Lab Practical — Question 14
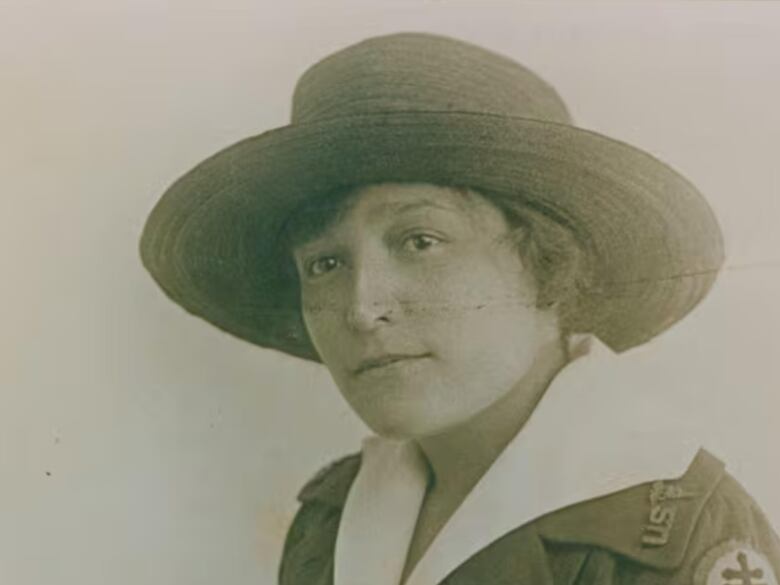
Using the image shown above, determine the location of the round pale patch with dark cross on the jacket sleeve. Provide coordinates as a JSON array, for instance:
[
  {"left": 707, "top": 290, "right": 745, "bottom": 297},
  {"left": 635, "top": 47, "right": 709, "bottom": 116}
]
[{"left": 694, "top": 541, "right": 778, "bottom": 585}]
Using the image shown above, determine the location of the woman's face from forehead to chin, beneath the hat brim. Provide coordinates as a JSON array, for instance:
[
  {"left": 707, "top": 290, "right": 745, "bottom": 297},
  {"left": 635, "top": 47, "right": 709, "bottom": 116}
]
[{"left": 295, "top": 183, "right": 558, "bottom": 438}]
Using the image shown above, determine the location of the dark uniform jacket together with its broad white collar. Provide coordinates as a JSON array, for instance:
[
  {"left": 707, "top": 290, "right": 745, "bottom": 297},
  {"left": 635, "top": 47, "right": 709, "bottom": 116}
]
[{"left": 279, "top": 344, "right": 780, "bottom": 585}]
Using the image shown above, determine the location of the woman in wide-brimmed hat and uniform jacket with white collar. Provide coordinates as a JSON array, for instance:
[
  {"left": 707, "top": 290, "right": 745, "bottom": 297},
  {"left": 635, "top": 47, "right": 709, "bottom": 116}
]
[{"left": 141, "top": 33, "right": 780, "bottom": 585}]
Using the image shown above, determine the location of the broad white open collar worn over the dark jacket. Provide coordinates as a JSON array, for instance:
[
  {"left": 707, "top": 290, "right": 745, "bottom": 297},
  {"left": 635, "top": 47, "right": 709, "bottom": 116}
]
[{"left": 334, "top": 339, "right": 698, "bottom": 585}]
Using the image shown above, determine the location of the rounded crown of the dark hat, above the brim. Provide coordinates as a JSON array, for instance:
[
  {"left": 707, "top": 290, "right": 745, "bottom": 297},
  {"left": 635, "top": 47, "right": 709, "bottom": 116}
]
[{"left": 292, "top": 33, "right": 571, "bottom": 124}]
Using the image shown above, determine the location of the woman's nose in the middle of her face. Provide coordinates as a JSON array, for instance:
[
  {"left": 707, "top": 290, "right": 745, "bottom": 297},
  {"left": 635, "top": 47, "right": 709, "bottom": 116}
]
[{"left": 346, "top": 258, "right": 398, "bottom": 331}]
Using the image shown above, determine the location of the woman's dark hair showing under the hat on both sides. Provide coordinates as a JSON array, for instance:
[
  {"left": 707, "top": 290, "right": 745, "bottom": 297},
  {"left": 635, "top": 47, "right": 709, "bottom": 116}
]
[{"left": 278, "top": 185, "right": 593, "bottom": 336}]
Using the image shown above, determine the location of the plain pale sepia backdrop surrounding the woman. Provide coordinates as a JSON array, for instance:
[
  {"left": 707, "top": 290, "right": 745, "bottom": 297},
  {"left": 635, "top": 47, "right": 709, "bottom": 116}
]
[{"left": 0, "top": 0, "right": 780, "bottom": 585}]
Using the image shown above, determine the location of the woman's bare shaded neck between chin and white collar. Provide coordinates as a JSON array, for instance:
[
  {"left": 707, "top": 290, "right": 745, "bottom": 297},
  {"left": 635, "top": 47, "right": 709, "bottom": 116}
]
[{"left": 417, "top": 340, "right": 569, "bottom": 506}]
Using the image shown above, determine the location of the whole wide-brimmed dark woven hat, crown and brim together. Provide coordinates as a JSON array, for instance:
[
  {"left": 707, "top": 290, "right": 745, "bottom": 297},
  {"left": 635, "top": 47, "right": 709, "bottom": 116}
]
[{"left": 140, "top": 33, "right": 723, "bottom": 360}]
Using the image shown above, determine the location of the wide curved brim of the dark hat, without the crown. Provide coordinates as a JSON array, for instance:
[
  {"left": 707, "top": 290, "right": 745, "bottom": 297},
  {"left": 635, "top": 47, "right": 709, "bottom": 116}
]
[{"left": 140, "top": 112, "right": 723, "bottom": 361}]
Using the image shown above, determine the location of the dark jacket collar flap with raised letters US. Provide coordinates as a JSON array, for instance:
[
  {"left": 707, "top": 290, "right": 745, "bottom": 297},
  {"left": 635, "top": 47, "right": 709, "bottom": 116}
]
[{"left": 538, "top": 449, "right": 737, "bottom": 570}]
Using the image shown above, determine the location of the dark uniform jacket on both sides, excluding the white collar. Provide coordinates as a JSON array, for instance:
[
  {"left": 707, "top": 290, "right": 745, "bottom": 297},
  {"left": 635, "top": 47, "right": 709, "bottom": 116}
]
[{"left": 279, "top": 450, "right": 780, "bottom": 585}]
